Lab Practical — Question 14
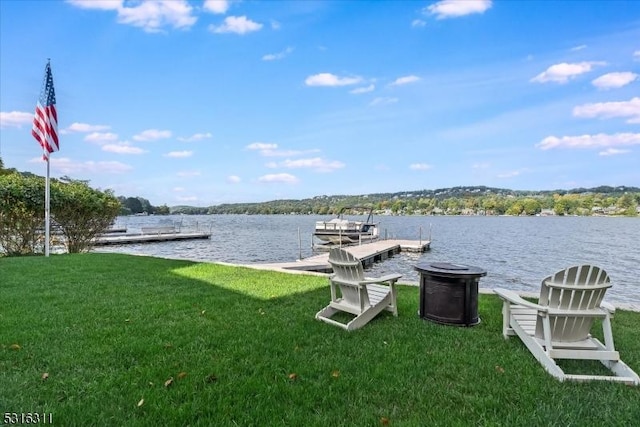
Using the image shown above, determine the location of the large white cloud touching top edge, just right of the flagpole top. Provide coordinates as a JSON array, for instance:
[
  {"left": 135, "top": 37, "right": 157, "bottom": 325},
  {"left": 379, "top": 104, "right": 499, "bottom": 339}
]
[{"left": 68, "top": 0, "right": 198, "bottom": 33}]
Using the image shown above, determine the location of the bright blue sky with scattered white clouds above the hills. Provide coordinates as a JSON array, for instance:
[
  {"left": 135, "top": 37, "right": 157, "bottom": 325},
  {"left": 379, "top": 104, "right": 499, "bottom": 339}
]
[{"left": 0, "top": 0, "right": 640, "bottom": 206}]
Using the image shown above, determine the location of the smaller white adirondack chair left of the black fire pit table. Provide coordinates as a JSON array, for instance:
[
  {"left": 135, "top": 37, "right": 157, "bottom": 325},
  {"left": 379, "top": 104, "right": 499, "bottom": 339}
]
[{"left": 316, "top": 248, "right": 402, "bottom": 331}]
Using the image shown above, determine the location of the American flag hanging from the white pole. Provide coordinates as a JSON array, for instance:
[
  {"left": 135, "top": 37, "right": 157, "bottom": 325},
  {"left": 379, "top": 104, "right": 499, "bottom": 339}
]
[{"left": 31, "top": 62, "right": 60, "bottom": 161}]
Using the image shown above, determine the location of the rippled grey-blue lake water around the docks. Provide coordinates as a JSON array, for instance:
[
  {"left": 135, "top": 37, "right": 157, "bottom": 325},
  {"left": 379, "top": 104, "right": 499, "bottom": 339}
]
[{"left": 97, "top": 215, "right": 640, "bottom": 309}]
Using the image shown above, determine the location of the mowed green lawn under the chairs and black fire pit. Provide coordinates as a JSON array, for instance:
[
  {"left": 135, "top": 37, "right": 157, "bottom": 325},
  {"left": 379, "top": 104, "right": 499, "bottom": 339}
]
[{"left": 0, "top": 253, "right": 640, "bottom": 426}]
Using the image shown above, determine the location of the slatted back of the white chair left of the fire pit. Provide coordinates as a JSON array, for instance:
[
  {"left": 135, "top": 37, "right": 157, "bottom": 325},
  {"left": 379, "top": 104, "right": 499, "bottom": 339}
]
[{"left": 329, "top": 248, "right": 370, "bottom": 309}]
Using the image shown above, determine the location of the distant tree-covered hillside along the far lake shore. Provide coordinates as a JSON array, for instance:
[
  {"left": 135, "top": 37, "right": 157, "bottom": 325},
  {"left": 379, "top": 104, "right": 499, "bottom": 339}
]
[{"left": 171, "top": 187, "right": 640, "bottom": 216}]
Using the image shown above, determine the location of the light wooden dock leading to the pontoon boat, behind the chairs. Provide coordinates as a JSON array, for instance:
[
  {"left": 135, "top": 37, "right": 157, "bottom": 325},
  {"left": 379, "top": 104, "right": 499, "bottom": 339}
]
[{"left": 250, "top": 240, "right": 431, "bottom": 273}]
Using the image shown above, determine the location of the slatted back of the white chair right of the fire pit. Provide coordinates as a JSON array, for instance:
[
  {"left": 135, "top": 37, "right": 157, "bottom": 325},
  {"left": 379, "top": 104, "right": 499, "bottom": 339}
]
[{"left": 536, "top": 265, "right": 611, "bottom": 342}]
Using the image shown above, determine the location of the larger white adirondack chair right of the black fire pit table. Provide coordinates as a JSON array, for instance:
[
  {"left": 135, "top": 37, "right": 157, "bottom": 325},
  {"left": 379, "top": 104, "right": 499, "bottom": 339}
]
[{"left": 494, "top": 265, "right": 640, "bottom": 385}]
